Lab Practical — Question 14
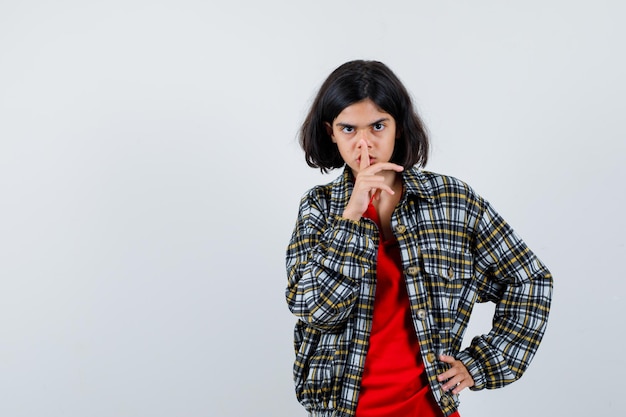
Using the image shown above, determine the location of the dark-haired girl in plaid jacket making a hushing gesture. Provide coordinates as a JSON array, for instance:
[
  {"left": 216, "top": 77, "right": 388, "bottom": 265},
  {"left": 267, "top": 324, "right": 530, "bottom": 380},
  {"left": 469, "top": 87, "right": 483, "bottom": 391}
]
[{"left": 286, "top": 61, "right": 552, "bottom": 417}]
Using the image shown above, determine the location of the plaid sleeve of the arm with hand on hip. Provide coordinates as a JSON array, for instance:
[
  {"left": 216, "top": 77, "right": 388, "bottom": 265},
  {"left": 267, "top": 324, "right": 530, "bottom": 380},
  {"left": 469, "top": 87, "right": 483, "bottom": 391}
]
[{"left": 457, "top": 203, "right": 552, "bottom": 390}]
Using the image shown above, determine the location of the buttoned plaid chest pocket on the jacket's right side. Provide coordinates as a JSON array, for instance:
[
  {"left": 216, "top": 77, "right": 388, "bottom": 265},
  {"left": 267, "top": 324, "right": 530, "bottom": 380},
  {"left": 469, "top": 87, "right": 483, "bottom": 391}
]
[{"left": 421, "top": 248, "right": 475, "bottom": 329}]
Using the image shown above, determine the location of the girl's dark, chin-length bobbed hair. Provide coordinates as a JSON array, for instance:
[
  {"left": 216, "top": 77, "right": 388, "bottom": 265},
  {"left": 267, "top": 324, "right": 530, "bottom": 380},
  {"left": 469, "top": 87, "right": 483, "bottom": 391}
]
[{"left": 300, "top": 60, "right": 429, "bottom": 172}]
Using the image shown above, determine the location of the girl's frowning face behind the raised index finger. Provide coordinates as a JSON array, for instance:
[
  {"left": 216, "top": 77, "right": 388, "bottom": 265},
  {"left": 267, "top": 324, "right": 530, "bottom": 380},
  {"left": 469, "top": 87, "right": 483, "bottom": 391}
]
[{"left": 326, "top": 99, "right": 396, "bottom": 175}]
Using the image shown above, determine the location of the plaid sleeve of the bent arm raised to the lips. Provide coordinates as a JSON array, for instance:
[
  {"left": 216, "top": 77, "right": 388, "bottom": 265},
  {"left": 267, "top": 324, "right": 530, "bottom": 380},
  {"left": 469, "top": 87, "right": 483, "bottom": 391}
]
[{"left": 286, "top": 189, "right": 377, "bottom": 330}]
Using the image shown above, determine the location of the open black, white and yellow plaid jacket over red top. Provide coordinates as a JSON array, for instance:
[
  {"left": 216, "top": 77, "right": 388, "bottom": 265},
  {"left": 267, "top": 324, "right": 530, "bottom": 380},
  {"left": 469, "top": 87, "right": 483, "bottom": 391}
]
[{"left": 286, "top": 168, "right": 552, "bottom": 417}]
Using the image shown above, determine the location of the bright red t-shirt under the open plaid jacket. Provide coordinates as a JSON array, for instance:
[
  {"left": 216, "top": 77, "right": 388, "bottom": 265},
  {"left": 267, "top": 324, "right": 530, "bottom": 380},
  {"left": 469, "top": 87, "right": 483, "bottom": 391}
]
[{"left": 356, "top": 204, "right": 459, "bottom": 417}]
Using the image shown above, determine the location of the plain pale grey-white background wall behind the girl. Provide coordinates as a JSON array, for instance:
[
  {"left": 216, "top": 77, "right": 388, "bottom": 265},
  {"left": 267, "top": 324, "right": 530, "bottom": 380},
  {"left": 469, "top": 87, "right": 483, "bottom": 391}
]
[{"left": 0, "top": 0, "right": 626, "bottom": 417}]
